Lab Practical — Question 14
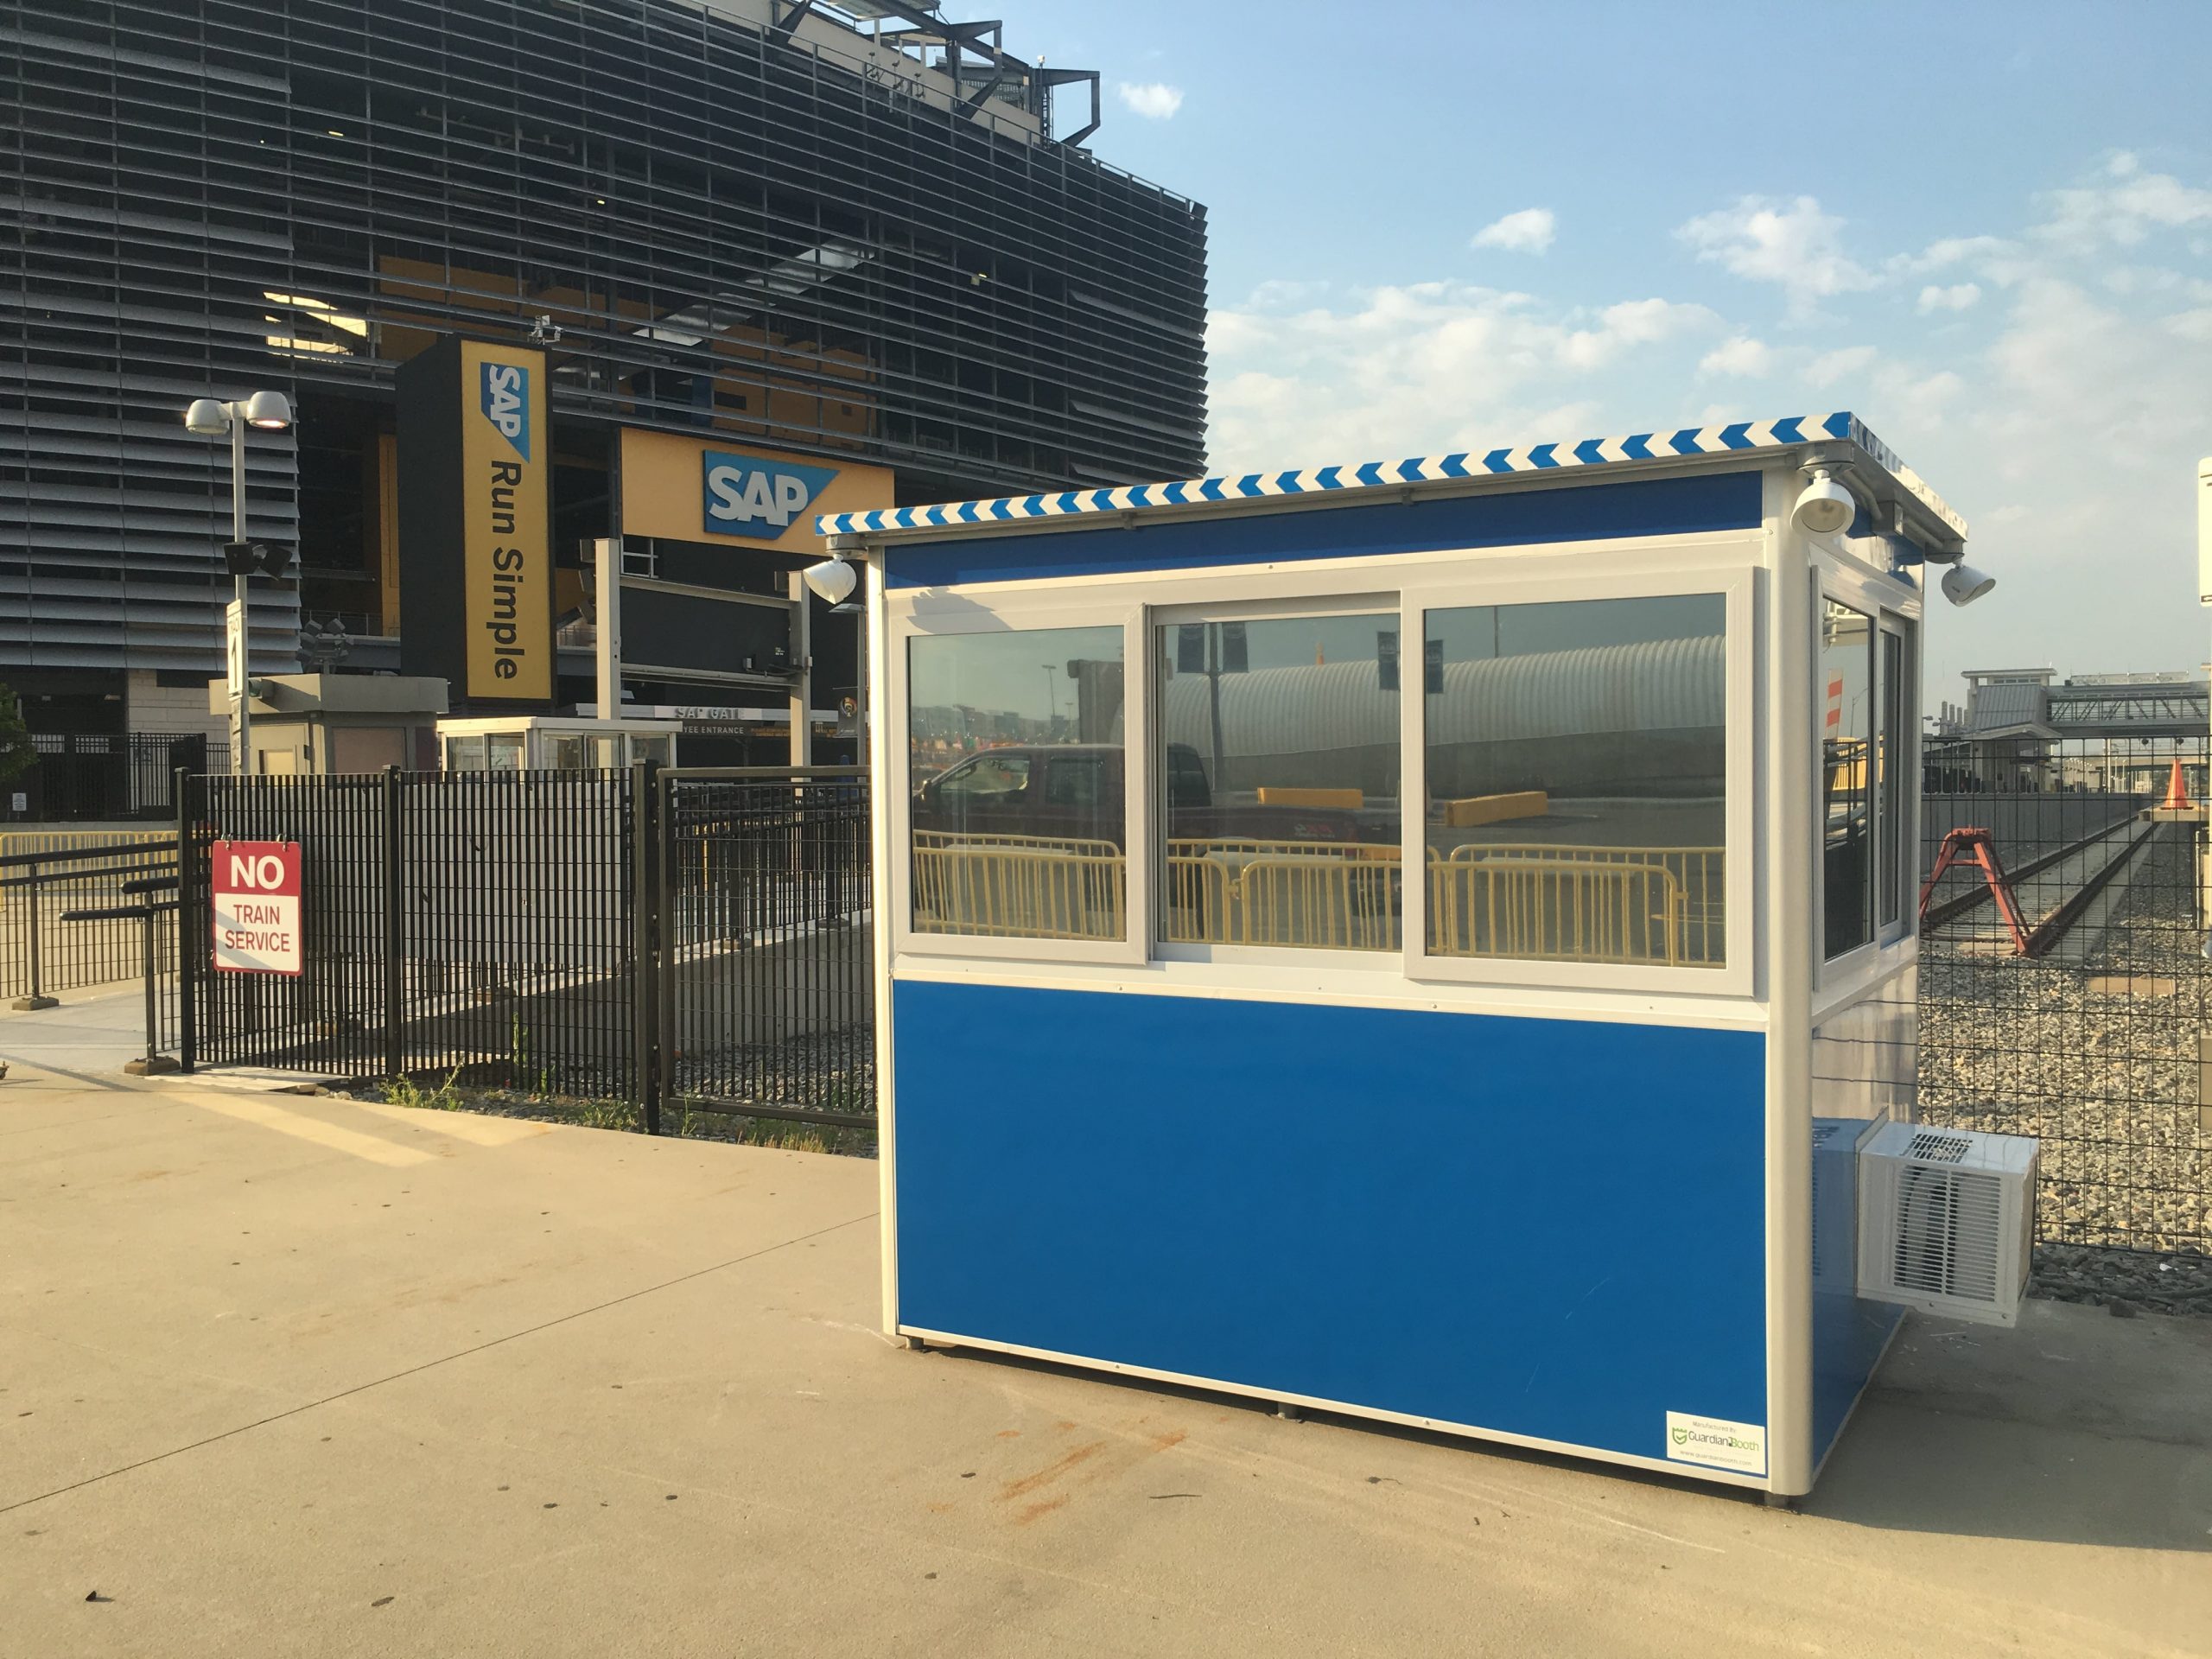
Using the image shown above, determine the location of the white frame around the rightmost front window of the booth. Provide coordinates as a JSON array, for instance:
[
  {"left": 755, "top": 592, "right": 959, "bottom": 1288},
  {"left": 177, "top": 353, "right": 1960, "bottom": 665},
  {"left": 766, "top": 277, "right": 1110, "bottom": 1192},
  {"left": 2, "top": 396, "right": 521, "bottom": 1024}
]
[{"left": 1398, "top": 559, "right": 1763, "bottom": 998}]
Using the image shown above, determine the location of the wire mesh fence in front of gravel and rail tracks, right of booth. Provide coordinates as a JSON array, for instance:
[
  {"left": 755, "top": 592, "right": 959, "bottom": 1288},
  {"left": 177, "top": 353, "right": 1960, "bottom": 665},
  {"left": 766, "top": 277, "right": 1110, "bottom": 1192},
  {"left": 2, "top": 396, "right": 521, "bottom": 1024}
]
[{"left": 1920, "top": 734, "right": 2212, "bottom": 1252}]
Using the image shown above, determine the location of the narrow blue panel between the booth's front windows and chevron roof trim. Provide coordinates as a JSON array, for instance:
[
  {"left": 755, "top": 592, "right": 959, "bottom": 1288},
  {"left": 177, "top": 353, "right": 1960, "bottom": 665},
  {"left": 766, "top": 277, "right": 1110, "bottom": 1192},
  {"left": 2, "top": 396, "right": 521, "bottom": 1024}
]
[{"left": 885, "top": 469, "right": 1765, "bottom": 588}]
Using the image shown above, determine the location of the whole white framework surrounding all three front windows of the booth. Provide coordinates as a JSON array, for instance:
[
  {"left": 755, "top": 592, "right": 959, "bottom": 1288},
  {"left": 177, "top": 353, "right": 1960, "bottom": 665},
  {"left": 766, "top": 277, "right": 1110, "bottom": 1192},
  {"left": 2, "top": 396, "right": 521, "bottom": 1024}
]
[{"left": 880, "top": 529, "right": 1772, "bottom": 1011}]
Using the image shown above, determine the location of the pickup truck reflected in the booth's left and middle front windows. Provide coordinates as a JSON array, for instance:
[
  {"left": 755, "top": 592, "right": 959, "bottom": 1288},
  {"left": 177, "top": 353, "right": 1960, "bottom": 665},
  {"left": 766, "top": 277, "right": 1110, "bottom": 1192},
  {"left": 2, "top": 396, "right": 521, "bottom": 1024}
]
[{"left": 913, "top": 743, "right": 1398, "bottom": 847}]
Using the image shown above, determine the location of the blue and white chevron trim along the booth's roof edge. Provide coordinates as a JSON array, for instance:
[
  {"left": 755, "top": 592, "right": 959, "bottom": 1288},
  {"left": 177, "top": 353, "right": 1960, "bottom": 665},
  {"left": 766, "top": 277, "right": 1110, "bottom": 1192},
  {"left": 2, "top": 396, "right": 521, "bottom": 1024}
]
[{"left": 814, "top": 410, "right": 1967, "bottom": 537}]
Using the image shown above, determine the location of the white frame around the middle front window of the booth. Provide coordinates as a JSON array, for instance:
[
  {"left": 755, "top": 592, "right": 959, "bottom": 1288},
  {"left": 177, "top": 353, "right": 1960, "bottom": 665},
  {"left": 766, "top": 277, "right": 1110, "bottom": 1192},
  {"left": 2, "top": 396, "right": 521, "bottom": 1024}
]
[{"left": 1144, "top": 583, "right": 1407, "bottom": 976}]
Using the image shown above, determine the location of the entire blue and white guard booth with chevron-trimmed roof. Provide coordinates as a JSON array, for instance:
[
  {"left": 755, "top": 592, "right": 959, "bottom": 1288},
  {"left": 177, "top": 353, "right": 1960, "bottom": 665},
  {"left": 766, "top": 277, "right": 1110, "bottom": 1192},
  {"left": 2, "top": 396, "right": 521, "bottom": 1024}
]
[{"left": 821, "top": 414, "right": 1964, "bottom": 1496}]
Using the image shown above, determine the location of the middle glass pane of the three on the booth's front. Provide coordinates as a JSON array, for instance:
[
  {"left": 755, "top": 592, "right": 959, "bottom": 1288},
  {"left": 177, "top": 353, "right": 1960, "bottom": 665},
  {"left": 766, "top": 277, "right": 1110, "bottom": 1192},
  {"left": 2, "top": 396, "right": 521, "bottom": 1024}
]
[{"left": 1153, "top": 611, "right": 1405, "bottom": 951}]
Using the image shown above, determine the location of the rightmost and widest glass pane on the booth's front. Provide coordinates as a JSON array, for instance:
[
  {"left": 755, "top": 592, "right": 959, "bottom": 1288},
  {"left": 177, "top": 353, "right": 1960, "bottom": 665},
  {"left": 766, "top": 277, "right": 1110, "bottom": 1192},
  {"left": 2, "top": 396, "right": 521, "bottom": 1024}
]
[{"left": 1409, "top": 593, "right": 1727, "bottom": 969}]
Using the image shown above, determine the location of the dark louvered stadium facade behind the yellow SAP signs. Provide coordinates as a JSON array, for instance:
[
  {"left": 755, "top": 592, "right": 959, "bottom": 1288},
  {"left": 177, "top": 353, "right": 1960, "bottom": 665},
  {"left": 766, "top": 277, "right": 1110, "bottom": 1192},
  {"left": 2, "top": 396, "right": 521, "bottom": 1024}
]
[{"left": 0, "top": 0, "right": 1205, "bottom": 747}]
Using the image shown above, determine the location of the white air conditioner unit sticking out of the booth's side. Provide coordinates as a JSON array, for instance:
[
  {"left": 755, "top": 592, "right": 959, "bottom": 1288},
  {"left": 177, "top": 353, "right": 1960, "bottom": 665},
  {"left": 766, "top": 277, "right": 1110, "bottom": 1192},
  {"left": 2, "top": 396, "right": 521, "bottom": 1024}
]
[{"left": 1858, "top": 1123, "right": 2037, "bottom": 1325}]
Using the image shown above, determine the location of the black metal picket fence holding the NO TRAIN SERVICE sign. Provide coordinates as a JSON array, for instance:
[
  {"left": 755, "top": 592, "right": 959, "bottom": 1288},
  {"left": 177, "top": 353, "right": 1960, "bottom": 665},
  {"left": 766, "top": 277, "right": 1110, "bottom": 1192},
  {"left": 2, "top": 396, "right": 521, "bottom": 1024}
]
[{"left": 179, "top": 767, "right": 874, "bottom": 1130}]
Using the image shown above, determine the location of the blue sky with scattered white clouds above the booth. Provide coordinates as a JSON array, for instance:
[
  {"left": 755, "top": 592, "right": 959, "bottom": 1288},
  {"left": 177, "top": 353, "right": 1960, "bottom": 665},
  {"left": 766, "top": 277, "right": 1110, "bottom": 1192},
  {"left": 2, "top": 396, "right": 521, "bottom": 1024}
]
[{"left": 986, "top": 0, "right": 2212, "bottom": 702}]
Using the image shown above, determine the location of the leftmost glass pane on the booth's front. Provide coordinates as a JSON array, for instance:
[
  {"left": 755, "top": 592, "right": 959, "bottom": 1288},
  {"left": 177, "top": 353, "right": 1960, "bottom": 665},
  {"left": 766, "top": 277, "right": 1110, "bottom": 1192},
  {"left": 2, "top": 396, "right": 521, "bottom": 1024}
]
[{"left": 907, "top": 626, "right": 1128, "bottom": 940}]
